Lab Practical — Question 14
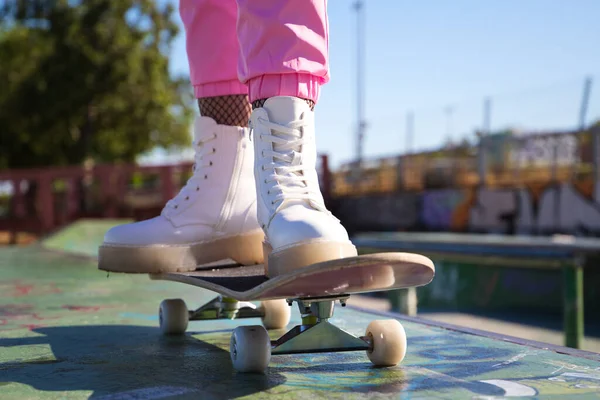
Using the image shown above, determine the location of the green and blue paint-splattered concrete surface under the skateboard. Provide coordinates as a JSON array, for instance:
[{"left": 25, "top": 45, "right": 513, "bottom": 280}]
[{"left": 0, "top": 247, "right": 600, "bottom": 399}]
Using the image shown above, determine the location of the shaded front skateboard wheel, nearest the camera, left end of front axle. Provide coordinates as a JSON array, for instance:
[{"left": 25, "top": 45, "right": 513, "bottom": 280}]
[{"left": 229, "top": 325, "right": 271, "bottom": 373}]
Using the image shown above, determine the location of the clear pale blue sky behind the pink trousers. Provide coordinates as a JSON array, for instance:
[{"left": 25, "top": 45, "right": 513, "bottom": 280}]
[{"left": 165, "top": 0, "right": 600, "bottom": 165}]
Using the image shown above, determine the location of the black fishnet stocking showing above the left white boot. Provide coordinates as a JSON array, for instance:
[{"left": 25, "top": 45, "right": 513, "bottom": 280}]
[{"left": 198, "top": 94, "right": 252, "bottom": 127}]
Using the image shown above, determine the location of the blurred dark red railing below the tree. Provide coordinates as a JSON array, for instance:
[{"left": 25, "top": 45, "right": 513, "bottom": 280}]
[{"left": 0, "top": 155, "right": 331, "bottom": 242}]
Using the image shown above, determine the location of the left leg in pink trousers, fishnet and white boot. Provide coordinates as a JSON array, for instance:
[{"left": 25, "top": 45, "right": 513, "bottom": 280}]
[{"left": 99, "top": 0, "right": 264, "bottom": 273}]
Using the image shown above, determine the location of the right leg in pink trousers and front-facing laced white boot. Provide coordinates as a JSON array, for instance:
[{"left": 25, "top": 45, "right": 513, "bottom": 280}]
[{"left": 237, "top": 0, "right": 357, "bottom": 276}]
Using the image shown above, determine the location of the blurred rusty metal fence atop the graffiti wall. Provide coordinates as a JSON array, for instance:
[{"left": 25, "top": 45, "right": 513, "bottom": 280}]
[{"left": 331, "top": 128, "right": 600, "bottom": 197}]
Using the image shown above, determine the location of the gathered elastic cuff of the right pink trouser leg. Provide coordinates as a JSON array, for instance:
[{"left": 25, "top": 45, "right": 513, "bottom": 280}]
[{"left": 248, "top": 74, "right": 325, "bottom": 103}]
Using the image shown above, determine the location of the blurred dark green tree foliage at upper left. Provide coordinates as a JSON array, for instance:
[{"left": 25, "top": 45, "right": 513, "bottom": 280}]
[{"left": 0, "top": 0, "right": 193, "bottom": 168}]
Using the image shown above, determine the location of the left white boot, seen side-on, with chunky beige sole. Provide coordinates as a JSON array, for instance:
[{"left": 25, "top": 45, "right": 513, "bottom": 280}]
[{"left": 98, "top": 117, "right": 264, "bottom": 273}]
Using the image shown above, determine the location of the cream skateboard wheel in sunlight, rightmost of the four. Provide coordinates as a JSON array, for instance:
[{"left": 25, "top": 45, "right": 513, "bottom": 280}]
[{"left": 365, "top": 319, "right": 406, "bottom": 367}]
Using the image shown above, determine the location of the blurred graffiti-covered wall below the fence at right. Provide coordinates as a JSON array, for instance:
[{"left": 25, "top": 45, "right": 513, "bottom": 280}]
[{"left": 335, "top": 182, "right": 600, "bottom": 236}]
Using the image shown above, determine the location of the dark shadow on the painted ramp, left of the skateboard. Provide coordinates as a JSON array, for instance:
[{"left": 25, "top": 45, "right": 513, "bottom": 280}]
[{"left": 0, "top": 325, "right": 285, "bottom": 399}]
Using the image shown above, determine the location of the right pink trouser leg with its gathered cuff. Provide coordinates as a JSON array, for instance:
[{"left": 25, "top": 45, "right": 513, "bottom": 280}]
[{"left": 237, "top": 0, "right": 329, "bottom": 105}]
